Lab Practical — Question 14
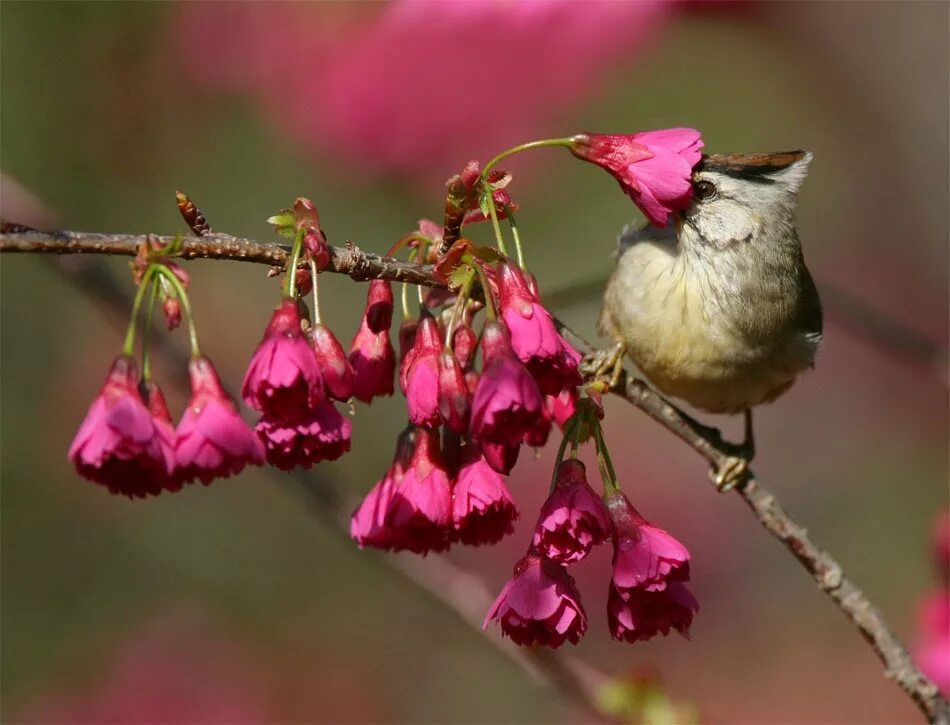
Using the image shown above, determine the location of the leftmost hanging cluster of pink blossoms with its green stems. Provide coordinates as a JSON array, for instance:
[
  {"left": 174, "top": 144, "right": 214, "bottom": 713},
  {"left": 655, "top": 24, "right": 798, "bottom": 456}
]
[{"left": 69, "top": 238, "right": 264, "bottom": 497}]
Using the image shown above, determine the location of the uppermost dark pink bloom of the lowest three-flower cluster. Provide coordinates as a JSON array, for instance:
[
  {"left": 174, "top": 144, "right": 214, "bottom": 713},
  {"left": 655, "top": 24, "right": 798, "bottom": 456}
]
[{"left": 533, "top": 458, "right": 612, "bottom": 564}]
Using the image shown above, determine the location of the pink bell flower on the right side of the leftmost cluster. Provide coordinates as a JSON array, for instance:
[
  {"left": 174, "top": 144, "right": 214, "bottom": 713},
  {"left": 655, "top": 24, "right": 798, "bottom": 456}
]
[{"left": 175, "top": 357, "right": 264, "bottom": 484}]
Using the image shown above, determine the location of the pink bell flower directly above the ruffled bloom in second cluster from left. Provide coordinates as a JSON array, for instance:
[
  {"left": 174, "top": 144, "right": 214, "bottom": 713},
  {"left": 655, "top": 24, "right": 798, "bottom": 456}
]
[{"left": 241, "top": 298, "right": 323, "bottom": 422}]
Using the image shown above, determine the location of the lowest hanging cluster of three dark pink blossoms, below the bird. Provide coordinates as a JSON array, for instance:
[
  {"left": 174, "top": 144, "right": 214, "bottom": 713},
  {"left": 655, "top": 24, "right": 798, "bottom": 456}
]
[{"left": 485, "top": 402, "right": 699, "bottom": 647}]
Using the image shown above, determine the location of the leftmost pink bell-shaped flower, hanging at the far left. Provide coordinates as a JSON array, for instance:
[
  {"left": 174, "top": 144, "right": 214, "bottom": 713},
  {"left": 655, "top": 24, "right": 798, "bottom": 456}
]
[{"left": 69, "top": 355, "right": 174, "bottom": 498}]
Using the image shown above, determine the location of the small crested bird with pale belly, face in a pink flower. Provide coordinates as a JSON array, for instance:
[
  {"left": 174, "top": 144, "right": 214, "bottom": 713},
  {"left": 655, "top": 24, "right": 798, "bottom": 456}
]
[{"left": 598, "top": 151, "right": 822, "bottom": 490}]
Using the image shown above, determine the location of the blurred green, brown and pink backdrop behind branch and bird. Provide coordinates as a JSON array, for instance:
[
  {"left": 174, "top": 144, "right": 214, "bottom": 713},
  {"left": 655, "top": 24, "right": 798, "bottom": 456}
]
[{"left": 0, "top": 0, "right": 950, "bottom": 723}]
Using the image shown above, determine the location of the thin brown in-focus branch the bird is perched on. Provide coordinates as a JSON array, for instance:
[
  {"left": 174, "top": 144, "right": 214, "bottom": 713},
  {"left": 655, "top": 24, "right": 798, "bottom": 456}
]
[{"left": 0, "top": 225, "right": 950, "bottom": 725}]
